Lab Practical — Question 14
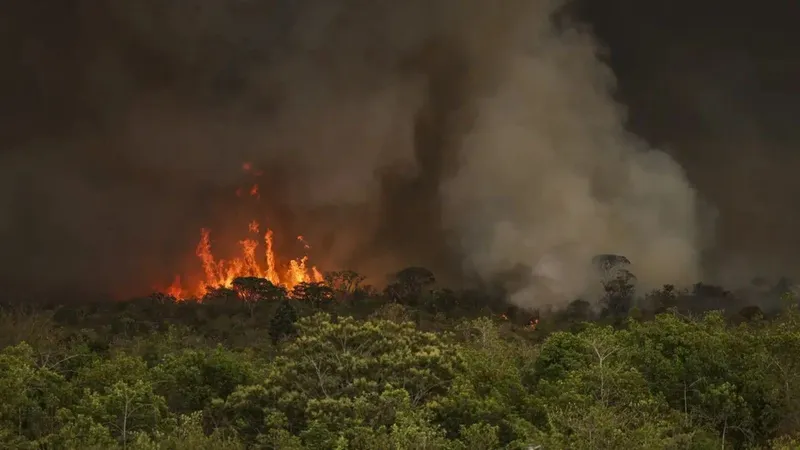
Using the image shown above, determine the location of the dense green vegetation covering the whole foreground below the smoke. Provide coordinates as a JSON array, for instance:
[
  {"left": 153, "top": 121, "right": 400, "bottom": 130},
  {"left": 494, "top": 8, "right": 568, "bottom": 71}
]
[{"left": 0, "top": 268, "right": 800, "bottom": 450}]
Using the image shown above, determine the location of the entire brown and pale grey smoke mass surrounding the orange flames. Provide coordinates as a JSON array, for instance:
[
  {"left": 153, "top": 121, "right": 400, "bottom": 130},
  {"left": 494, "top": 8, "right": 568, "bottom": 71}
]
[{"left": 0, "top": 0, "right": 792, "bottom": 305}]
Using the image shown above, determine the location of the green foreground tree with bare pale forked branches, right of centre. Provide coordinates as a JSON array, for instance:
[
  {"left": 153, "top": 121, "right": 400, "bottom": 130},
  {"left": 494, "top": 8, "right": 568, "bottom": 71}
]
[{"left": 536, "top": 326, "right": 693, "bottom": 448}]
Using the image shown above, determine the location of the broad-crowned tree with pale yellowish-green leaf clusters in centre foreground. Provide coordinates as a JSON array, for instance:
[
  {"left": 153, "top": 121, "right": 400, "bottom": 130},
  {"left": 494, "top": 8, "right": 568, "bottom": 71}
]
[{"left": 222, "top": 313, "right": 459, "bottom": 448}]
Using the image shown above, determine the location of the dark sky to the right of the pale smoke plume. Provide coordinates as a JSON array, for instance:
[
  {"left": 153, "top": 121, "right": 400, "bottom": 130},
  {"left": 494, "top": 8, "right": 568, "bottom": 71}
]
[{"left": 581, "top": 0, "right": 800, "bottom": 282}]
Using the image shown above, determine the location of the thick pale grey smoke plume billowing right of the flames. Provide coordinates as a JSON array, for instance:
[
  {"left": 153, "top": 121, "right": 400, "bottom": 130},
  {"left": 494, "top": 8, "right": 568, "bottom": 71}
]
[{"left": 442, "top": 15, "right": 703, "bottom": 304}]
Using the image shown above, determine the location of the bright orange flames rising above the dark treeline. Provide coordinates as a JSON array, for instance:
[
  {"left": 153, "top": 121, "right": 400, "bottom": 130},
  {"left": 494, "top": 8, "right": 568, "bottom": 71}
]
[{"left": 164, "top": 163, "right": 323, "bottom": 299}]
